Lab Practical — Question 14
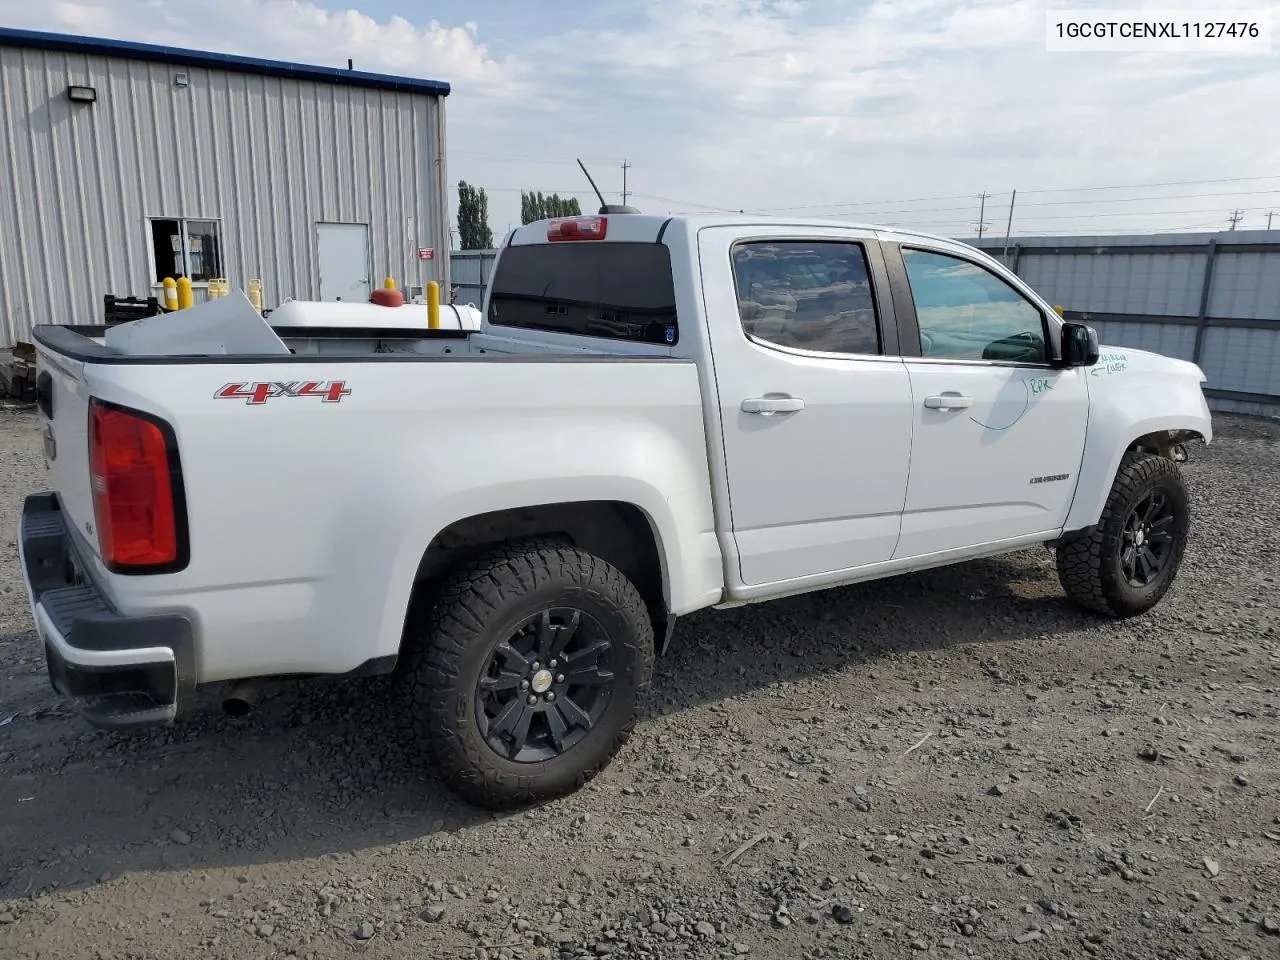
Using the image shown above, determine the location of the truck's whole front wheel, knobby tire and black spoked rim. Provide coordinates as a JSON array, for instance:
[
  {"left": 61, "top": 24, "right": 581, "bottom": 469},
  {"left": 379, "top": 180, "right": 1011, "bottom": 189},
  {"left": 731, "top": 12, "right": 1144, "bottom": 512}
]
[{"left": 1057, "top": 451, "right": 1190, "bottom": 617}]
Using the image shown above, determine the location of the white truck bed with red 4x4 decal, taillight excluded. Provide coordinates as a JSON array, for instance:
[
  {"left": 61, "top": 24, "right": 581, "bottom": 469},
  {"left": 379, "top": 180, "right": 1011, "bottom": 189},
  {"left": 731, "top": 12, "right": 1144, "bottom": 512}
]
[{"left": 27, "top": 326, "right": 721, "bottom": 682}]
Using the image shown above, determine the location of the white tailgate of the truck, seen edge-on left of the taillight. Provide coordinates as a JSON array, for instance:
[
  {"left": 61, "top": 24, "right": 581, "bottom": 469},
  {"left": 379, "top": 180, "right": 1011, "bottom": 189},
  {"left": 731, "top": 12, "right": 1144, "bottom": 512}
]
[{"left": 36, "top": 343, "right": 97, "bottom": 553}]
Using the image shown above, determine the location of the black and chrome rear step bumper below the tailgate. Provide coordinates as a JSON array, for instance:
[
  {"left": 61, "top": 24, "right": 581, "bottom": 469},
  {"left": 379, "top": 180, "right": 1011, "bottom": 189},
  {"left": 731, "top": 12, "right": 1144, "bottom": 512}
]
[{"left": 18, "top": 493, "right": 195, "bottom": 728}]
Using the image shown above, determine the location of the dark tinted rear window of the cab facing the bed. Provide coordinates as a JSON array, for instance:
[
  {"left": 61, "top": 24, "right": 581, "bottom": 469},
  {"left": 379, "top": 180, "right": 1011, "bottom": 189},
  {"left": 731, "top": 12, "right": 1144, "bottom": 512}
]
[{"left": 489, "top": 241, "right": 680, "bottom": 347}]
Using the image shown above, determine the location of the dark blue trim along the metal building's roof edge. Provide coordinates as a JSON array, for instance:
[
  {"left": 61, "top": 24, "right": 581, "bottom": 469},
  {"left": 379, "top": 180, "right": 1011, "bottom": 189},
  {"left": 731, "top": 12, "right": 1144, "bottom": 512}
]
[{"left": 0, "top": 27, "right": 449, "bottom": 97}]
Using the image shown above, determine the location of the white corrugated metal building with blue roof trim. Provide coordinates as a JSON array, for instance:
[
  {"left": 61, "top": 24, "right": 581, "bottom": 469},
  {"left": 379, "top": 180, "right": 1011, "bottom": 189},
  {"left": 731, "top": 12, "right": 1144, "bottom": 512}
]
[{"left": 0, "top": 29, "right": 449, "bottom": 347}]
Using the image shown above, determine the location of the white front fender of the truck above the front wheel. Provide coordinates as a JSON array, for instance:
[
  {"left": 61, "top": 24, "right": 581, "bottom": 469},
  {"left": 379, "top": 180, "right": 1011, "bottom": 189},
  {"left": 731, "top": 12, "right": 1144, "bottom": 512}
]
[{"left": 1064, "top": 347, "right": 1213, "bottom": 531}]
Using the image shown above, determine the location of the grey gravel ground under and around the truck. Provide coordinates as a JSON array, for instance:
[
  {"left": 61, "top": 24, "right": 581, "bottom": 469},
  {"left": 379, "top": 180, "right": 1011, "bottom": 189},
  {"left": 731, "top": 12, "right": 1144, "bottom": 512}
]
[{"left": 0, "top": 410, "right": 1280, "bottom": 960}]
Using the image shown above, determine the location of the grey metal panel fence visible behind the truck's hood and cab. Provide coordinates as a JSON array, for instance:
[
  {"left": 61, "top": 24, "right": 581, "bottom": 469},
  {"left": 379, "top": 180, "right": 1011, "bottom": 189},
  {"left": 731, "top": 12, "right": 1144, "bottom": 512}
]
[{"left": 452, "top": 230, "right": 1280, "bottom": 416}]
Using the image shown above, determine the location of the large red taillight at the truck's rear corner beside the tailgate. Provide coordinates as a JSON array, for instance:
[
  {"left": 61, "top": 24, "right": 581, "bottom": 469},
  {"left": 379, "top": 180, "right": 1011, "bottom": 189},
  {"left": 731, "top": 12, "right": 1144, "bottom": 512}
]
[{"left": 88, "top": 401, "right": 179, "bottom": 568}]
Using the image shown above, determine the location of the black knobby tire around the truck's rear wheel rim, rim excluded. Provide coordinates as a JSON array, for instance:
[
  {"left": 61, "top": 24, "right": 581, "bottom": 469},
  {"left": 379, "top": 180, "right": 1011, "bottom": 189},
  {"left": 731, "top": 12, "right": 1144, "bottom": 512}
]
[{"left": 403, "top": 540, "right": 654, "bottom": 809}]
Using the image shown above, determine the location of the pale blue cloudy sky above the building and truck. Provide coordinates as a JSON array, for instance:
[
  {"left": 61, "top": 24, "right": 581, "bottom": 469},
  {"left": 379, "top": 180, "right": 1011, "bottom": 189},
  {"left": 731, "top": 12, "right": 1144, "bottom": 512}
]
[{"left": 0, "top": 0, "right": 1280, "bottom": 236}]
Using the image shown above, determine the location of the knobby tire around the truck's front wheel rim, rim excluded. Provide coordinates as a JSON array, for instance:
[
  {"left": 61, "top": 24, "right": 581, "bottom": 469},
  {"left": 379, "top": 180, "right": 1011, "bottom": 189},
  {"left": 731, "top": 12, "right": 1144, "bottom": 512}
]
[{"left": 1057, "top": 451, "right": 1190, "bottom": 618}]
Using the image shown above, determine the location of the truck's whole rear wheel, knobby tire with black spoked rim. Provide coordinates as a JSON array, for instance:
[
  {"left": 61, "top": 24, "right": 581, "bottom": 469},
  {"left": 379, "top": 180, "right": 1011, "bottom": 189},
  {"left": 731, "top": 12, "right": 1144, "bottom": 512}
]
[{"left": 406, "top": 543, "right": 653, "bottom": 809}]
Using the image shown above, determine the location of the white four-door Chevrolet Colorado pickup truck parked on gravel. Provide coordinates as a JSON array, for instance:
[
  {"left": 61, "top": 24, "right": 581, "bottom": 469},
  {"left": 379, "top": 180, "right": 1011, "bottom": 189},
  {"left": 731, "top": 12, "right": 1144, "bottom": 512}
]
[{"left": 20, "top": 212, "right": 1212, "bottom": 806}]
